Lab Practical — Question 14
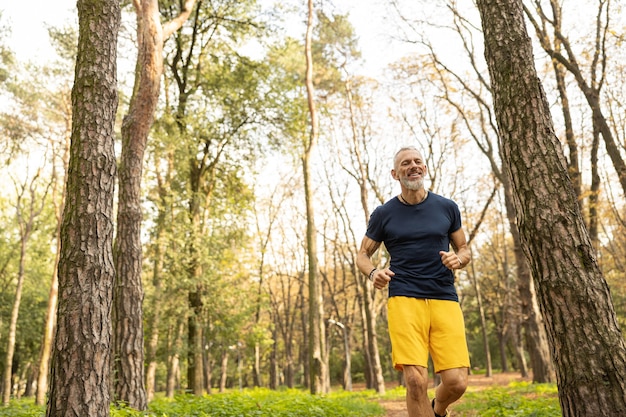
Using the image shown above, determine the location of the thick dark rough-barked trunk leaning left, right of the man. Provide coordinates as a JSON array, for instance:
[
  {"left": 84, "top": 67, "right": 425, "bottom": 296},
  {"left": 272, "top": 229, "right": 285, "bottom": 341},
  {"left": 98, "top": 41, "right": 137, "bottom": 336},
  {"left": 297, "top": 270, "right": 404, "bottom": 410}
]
[{"left": 477, "top": 0, "right": 626, "bottom": 416}]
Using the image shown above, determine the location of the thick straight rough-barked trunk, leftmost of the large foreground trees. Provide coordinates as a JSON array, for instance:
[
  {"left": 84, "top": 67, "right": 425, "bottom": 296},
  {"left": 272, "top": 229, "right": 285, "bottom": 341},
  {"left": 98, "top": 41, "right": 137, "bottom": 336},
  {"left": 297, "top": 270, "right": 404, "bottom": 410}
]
[{"left": 46, "top": 0, "right": 120, "bottom": 417}]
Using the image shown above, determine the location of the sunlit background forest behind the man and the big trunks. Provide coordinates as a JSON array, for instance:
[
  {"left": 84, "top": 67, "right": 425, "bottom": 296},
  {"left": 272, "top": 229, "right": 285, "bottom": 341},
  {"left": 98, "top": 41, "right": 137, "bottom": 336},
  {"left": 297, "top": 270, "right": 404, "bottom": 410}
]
[{"left": 0, "top": 0, "right": 626, "bottom": 402}]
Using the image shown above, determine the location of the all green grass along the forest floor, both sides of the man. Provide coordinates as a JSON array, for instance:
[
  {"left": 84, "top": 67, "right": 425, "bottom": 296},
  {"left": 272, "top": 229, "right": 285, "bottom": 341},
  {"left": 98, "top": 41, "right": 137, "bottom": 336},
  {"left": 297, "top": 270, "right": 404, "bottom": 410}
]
[{"left": 0, "top": 382, "right": 561, "bottom": 417}]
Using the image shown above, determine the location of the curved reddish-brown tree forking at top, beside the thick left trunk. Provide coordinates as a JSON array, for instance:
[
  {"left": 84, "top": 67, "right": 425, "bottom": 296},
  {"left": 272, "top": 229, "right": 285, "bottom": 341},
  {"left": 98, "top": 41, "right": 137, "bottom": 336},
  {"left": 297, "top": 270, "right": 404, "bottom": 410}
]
[{"left": 113, "top": 0, "right": 195, "bottom": 410}]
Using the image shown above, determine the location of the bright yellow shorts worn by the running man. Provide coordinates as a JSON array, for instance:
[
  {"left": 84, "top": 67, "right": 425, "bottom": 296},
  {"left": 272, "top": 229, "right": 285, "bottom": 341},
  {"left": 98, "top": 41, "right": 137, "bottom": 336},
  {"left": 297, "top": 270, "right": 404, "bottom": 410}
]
[{"left": 387, "top": 297, "right": 470, "bottom": 372}]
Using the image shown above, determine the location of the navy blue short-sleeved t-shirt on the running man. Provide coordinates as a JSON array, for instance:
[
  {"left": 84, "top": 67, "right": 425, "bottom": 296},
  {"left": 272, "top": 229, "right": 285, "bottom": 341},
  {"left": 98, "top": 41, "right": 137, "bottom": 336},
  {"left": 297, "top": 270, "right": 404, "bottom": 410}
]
[{"left": 365, "top": 192, "right": 461, "bottom": 301}]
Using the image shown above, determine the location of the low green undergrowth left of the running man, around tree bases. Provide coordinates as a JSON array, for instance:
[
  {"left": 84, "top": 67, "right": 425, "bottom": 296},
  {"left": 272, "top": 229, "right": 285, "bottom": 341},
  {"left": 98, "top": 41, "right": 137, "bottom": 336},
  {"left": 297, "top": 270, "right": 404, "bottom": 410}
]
[{"left": 0, "top": 388, "right": 385, "bottom": 417}]
